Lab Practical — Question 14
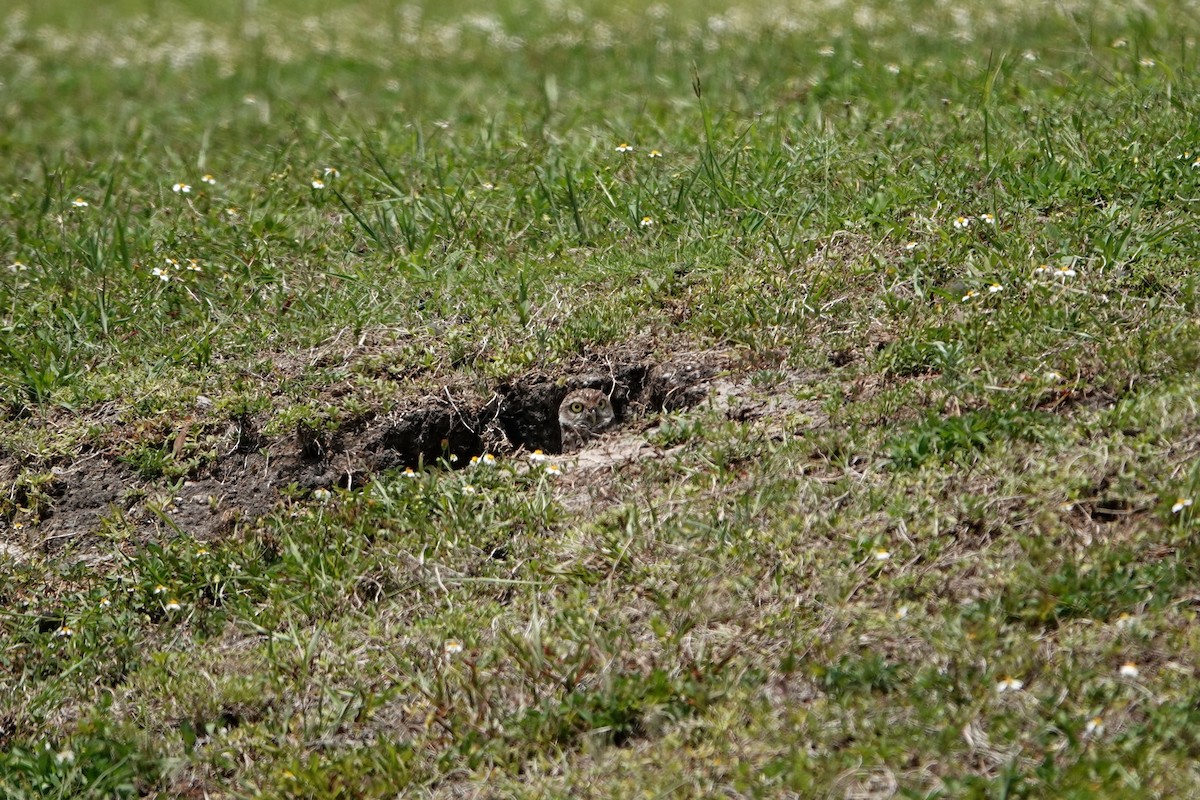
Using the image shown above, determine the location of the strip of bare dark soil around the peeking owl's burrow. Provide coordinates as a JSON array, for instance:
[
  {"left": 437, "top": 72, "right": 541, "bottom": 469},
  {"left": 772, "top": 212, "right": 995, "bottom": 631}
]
[{"left": 0, "top": 351, "right": 811, "bottom": 559}]
